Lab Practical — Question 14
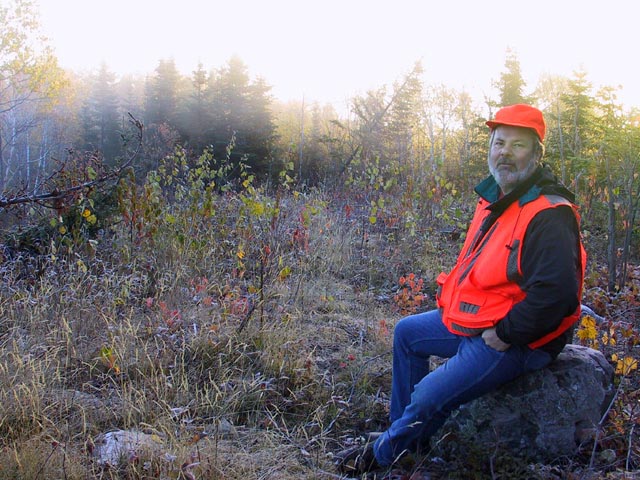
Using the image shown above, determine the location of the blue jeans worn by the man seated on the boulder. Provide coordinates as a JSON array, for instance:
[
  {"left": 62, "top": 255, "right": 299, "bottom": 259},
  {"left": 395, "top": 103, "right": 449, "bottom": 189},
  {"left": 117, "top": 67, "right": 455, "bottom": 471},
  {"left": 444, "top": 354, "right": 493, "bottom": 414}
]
[{"left": 374, "top": 310, "right": 552, "bottom": 466}]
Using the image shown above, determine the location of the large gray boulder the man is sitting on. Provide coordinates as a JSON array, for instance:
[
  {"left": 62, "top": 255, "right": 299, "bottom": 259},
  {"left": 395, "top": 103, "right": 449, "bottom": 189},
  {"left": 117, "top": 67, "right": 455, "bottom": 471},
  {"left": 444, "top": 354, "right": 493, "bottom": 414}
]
[{"left": 431, "top": 345, "right": 614, "bottom": 462}]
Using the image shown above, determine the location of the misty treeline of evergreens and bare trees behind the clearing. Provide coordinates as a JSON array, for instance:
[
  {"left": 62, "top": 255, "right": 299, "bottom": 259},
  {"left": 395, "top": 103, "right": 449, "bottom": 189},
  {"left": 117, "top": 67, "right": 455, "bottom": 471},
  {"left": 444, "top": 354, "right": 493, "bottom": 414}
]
[{"left": 0, "top": 0, "right": 640, "bottom": 288}]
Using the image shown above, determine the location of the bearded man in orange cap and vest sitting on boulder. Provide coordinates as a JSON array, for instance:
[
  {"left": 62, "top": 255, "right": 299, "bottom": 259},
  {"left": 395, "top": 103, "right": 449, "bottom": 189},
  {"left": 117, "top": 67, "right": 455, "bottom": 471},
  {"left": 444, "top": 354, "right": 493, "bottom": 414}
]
[{"left": 337, "top": 104, "right": 586, "bottom": 474}]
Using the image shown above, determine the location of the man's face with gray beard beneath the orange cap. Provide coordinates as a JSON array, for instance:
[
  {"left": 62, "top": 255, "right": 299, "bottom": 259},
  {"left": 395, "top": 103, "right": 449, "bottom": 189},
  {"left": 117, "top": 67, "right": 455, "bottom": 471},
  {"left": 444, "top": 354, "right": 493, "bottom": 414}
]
[{"left": 489, "top": 125, "right": 539, "bottom": 194}]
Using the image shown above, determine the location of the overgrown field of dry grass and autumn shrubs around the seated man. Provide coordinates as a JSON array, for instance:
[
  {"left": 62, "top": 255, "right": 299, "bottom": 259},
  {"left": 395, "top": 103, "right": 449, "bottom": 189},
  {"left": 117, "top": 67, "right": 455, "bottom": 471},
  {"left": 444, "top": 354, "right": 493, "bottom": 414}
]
[{"left": 0, "top": 164, "right": 640, "bottom": 480}]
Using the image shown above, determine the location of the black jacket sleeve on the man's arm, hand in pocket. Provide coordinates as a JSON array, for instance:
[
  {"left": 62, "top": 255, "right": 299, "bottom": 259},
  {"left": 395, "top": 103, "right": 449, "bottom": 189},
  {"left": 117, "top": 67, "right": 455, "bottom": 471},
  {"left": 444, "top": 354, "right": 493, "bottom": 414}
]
[{"left": 496, "top": 206, "right": 580, "bottom": 345}]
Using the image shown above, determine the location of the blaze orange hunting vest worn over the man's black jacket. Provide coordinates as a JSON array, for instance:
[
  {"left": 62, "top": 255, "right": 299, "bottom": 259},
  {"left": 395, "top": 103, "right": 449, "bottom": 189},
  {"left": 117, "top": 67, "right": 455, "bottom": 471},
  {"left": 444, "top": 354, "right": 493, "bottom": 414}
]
[{"left": 436, "top": 195, "right": 586, "bottom": 348}]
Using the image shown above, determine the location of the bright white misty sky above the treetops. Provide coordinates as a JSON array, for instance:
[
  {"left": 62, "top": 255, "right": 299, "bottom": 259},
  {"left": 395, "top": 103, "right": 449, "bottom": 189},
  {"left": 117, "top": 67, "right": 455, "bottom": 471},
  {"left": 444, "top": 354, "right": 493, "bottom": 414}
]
[{"left": 36, "top": 0, "right": 640, "bottom": 107}]
